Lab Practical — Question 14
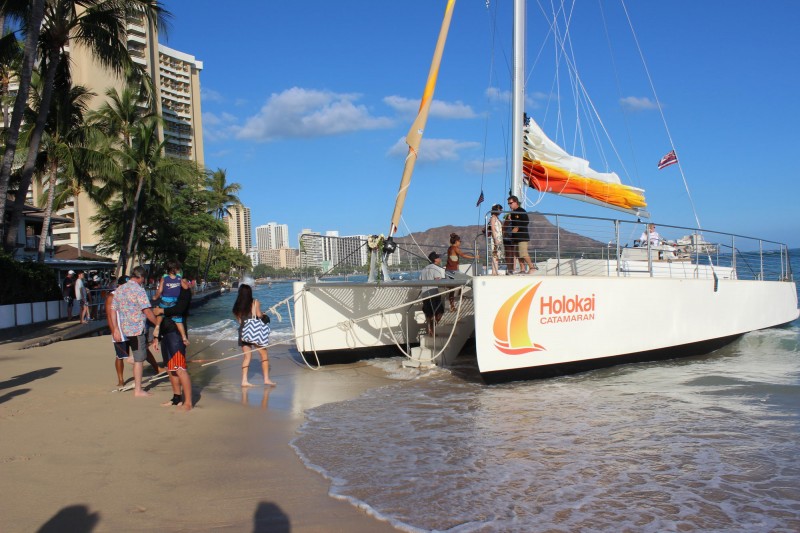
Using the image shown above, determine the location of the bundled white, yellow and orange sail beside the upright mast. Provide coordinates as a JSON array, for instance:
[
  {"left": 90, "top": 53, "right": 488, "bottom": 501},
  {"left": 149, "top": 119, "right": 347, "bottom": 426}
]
[{"left": 522, "top": 119, "right": 648, "bottom": 216}]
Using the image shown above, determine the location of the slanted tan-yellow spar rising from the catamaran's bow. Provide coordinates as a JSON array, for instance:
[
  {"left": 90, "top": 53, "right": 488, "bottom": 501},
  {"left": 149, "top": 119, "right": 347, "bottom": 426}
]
[{"left": 389, "top": 0, "right": 456, "bottom": 237}]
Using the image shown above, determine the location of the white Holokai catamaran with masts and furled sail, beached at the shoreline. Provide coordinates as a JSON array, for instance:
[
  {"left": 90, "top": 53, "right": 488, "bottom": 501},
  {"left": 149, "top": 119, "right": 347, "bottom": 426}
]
[{"left": 294, "top": 0, "right": 798, "bottom": 381}]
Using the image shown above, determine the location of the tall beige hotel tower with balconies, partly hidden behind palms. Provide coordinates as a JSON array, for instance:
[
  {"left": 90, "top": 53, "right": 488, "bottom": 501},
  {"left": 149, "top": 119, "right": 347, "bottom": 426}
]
[{"left": 37, "top": 14, "right": 204, "bottom": 251}]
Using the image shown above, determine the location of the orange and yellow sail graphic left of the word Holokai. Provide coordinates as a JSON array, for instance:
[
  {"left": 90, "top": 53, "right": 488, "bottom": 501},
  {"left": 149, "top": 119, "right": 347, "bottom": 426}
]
[{"left": 493, "top": 281, "right": 545, "bottom": 355}]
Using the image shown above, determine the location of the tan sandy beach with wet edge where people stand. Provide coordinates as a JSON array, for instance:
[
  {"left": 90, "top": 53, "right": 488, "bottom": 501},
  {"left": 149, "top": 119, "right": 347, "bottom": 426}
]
[{"left": 0, "top": 328, "right": 394, "bottom": 532}]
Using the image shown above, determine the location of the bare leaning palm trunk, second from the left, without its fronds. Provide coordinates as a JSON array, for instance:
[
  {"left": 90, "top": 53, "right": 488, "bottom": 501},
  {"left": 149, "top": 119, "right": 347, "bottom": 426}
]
[{"left": 5, "top": 50, "right": 59, "bottom": 253}]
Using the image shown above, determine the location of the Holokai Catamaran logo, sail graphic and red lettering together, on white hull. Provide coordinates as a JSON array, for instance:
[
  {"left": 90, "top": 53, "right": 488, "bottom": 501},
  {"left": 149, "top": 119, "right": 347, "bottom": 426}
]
[{"left": 493, "top": 281, "right": 595, "bottom": 355}]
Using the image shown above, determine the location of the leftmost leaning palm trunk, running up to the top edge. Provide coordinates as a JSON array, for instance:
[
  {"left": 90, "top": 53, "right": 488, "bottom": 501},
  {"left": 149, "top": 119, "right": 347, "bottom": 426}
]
[{"left": 0, "top": 0, "right": 45, "bottom": 245}]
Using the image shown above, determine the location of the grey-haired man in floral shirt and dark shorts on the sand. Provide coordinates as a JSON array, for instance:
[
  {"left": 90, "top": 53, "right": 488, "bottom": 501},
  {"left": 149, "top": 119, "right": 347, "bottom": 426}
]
[{"left": 111, "top": 266, "right": 156, "bottom": 397}]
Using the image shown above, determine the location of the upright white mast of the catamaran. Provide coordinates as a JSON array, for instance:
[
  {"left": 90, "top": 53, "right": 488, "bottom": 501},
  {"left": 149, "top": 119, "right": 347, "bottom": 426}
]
[{"left": 511, "top": 0, "right": 525, "bottom": 197}]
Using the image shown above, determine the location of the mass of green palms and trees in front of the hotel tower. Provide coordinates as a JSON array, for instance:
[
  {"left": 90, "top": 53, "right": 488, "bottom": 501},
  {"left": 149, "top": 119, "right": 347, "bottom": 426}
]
[{"left": 0, "top": 0, "right": 250, "bottom": 280}]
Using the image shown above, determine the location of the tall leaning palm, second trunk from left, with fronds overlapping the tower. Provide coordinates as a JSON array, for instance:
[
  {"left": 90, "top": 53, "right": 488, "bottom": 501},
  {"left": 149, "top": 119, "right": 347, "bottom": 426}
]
[{"left": 0, "top": 0, "right": 168, "bottom": 249}]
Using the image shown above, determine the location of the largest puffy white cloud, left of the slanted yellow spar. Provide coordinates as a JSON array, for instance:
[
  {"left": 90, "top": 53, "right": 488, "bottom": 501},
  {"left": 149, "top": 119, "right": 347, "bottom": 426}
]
[{"left": 236, "top": 87, "right": 393, "bottom": 142}]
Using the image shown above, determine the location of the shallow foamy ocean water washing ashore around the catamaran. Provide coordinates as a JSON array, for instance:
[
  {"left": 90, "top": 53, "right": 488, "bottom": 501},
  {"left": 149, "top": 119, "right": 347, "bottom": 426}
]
[{"left": 193, "top": 268, "right": 800, "bottom": 532}]
